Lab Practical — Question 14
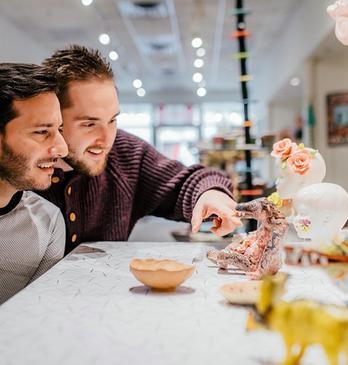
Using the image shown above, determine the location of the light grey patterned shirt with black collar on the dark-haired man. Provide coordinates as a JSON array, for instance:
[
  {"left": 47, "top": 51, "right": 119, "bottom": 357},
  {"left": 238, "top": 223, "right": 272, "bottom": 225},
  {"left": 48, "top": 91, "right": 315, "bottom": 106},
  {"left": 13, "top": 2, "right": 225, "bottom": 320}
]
[{"left": 0, "top": 191, "right": 65, "bottom": 304}]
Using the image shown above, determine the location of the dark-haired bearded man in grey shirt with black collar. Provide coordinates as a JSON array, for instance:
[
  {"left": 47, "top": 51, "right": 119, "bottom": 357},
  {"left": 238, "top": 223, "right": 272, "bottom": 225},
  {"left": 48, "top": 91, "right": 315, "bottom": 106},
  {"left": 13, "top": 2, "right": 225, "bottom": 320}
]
[{"left": 0, "top": 63, "right": 68, "bottom": 304}]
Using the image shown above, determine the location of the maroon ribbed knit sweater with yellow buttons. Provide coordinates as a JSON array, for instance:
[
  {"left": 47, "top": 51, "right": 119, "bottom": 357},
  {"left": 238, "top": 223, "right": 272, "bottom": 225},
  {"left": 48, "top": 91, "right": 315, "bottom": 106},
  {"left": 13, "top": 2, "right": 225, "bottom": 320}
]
[{"left": 39, "top": 130, "right": 232, "bottom": 253}]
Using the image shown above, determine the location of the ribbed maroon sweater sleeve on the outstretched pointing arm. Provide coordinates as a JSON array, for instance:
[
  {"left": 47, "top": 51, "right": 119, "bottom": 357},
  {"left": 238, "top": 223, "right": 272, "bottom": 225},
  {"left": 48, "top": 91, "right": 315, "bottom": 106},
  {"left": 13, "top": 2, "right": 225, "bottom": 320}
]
[{"left": 121, "top": 132, "right": 232, "bottom": 221}]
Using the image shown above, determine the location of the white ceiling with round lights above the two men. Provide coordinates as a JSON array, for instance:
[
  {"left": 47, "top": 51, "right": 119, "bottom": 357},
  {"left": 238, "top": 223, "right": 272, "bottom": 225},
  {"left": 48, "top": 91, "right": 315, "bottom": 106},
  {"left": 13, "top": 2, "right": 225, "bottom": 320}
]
[{"left": 0, "top": 0, "right": 303, "bottom": 97}]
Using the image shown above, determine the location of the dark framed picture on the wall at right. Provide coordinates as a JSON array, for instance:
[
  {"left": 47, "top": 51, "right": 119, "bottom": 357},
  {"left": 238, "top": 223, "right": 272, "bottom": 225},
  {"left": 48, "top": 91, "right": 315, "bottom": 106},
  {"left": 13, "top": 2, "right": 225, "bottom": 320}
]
[{"left": 326, "top": 92, "right": 348, "bottom": 146}]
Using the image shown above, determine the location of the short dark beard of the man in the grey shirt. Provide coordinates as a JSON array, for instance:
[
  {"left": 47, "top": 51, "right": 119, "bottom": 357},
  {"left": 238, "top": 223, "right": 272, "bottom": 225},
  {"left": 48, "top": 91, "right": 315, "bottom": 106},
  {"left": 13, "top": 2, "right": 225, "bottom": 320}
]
[{"left": 0, "top": 140, "right": 48, "bottom": 190}]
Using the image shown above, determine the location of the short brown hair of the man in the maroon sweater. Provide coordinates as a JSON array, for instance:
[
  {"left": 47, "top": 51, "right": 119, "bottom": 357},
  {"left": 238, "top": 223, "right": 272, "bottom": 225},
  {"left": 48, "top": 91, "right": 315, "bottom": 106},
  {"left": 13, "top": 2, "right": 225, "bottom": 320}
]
[{"left": 43, "top": 45, "right": 114, "bottom": 108}]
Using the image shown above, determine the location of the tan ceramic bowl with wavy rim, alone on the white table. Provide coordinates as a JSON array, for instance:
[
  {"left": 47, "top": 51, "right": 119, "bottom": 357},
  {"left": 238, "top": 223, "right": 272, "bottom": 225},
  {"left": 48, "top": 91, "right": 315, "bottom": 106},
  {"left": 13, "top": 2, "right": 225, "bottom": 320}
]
[{"left": 129, "top": 259, "right": 195, "bottom": 290}]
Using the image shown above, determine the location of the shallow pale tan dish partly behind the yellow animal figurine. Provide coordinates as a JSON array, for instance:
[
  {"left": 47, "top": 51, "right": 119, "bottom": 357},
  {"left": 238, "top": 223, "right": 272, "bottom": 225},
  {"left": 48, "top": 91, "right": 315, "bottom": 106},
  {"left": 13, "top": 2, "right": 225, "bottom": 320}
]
[{"left": 219, "top": 280, "right": 261, "bottom": 304}]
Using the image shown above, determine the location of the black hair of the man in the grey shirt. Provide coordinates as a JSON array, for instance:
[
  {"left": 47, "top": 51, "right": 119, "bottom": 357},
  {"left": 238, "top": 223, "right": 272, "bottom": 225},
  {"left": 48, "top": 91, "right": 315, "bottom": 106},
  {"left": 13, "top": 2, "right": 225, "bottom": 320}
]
[{"left": 0, "top": 63, "right": 58, "bottom": 133}]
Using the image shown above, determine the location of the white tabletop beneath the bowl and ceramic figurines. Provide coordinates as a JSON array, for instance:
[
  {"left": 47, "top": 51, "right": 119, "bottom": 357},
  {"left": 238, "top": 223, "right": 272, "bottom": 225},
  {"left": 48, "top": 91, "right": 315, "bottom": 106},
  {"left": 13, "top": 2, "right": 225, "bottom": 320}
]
[{"left": 0, "top": 242, "right": 348, "bottom": 365}]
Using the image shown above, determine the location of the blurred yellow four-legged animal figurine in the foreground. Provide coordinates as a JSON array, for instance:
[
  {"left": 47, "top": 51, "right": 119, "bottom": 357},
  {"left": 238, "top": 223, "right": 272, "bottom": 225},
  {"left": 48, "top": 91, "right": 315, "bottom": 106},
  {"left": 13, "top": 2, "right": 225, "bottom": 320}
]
[{"left": 247, "top": 273, "right": 348, "bottom": 365}]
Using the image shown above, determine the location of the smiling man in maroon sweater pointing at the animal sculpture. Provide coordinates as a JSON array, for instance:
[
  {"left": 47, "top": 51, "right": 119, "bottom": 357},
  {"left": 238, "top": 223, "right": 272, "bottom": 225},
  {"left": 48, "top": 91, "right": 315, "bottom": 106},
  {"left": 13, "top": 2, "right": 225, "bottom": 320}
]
[{"left": 42, "top": 46, "right": 240, "bottom": 253}]
